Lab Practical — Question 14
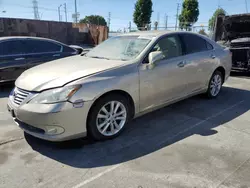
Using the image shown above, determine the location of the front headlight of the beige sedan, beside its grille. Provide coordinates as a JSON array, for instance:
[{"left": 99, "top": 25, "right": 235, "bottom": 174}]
[{"left": 29, "top": 85, "right": 81, "bottom": 104}]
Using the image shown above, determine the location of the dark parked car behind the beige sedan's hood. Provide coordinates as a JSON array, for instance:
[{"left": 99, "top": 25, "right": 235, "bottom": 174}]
[{"left": 0, "top": 37, "right": 77, "bottom": 83}]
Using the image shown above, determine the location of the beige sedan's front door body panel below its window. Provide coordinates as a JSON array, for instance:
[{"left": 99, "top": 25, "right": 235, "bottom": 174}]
[{"left": 139, "top": 57, "right": 188, "bottom": 111}]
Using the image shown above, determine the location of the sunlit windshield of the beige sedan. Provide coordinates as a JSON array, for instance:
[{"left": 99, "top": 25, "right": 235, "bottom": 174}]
[{"left": 86, "top": 36, "right": 151, "bottom": 61}]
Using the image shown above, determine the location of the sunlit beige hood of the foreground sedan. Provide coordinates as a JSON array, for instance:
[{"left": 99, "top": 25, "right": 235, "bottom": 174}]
[{"left": 15, "top": 55, "right": 124, "bottom": 92}]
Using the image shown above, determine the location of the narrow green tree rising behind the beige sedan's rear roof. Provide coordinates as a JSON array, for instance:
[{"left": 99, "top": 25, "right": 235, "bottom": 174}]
[{"left": 179, "top": 0, "right": 200, "bottom": 30}]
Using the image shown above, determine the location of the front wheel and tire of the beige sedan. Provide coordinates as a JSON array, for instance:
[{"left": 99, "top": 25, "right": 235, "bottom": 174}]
[{"left": 87, "top": 95, "right": 131, "bottom": 140}]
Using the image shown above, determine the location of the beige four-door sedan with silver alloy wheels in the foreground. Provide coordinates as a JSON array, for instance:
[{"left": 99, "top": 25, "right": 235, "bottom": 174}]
[{"left": 8, "top": 31, "right": 231, "bottom": 141}]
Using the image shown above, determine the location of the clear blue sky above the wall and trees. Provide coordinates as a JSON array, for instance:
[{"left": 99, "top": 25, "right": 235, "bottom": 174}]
[{"left": 0, "top": 0, "right": 250, "bottom": 31}]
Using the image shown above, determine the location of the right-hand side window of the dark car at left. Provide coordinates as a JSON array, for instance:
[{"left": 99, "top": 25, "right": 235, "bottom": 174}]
[{"left": 25, "top": 39, "right": 61, "bottom": 53}]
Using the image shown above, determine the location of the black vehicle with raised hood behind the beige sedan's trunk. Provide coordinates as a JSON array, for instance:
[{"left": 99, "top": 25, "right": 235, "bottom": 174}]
[{"left": 214, "top": 14, "right": 250, "bottom": 72}]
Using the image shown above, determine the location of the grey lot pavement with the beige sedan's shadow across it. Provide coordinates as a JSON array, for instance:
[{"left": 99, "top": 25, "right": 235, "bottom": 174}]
[{"left": 0, "top": 75, "right": 250, "bottom": 188}]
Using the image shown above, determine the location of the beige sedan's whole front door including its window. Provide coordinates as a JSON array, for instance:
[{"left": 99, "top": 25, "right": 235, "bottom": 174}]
[{"left": 139, "top": 35, "right": 189, "bottom": 111}]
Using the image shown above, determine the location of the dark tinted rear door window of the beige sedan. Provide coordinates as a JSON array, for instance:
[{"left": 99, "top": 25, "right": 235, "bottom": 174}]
[{"left": 181, "top": 34, "right": 208, "bottom": 54}]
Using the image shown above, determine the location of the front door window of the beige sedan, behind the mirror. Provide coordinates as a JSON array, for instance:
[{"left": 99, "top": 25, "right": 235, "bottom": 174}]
[{"left": 152, "top": 36, "right": 182, "bottom": 59}]
